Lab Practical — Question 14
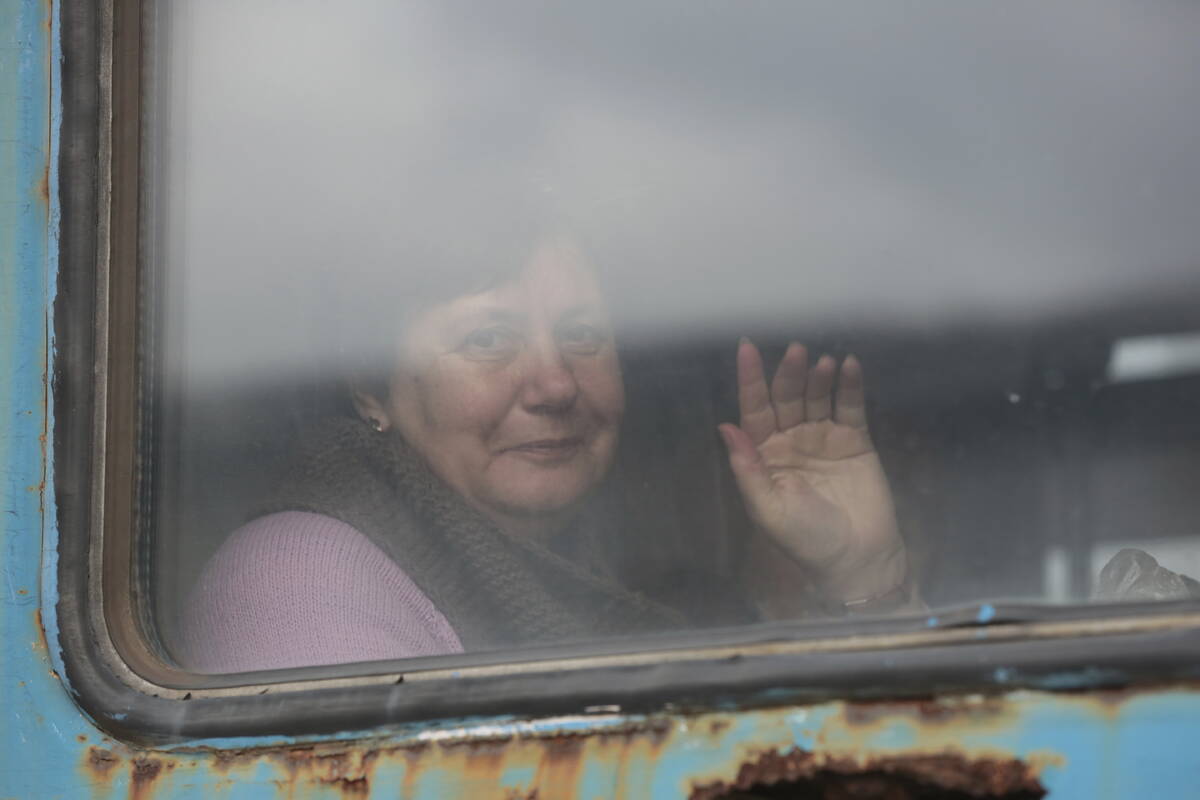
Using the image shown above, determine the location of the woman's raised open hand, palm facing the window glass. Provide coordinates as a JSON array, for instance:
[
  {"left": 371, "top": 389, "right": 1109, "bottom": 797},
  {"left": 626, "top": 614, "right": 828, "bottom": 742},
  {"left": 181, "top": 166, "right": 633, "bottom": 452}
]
[{"left": 719, "top": 339, "right": 907, "bottom": 603}]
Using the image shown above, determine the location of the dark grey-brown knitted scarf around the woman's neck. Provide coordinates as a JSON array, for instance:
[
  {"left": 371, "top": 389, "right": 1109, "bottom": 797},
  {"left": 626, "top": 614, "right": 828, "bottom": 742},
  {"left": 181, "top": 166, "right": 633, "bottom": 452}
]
[{"left": 263, "top": 417, "right": 686, "bottom": 650}]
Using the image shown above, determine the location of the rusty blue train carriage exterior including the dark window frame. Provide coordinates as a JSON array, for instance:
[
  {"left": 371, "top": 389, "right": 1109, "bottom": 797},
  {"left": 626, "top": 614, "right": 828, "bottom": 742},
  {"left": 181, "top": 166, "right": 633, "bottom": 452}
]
[{"left": 7, "top": 0, "right": 1200, "bottom": 799}]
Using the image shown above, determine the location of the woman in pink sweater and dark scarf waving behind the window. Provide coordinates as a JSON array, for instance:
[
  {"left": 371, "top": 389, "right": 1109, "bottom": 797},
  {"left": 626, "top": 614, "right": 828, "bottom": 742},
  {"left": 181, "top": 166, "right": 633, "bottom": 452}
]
[{"left": 177, "top": 240, "right": 916, "bottom": 672}]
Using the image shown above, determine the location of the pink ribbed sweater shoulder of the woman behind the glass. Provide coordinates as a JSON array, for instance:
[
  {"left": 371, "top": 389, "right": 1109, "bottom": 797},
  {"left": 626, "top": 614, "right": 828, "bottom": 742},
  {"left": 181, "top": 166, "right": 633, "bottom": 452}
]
[{"left": 181, "top": 511, "right": 462, "bottom": 673}]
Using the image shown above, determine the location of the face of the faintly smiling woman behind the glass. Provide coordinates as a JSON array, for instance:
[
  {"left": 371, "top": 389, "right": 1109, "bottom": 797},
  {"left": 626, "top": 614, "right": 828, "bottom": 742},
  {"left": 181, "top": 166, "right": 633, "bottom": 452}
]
[{"left": 360, "top": 242, "right": 625, "bottom": 530}]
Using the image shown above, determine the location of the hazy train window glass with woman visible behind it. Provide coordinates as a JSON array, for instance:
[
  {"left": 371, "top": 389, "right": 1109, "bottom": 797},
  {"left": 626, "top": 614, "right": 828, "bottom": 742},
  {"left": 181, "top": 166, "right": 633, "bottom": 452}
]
[{"left": 143, "top": 0, "right": 1200, "bottom": 672}]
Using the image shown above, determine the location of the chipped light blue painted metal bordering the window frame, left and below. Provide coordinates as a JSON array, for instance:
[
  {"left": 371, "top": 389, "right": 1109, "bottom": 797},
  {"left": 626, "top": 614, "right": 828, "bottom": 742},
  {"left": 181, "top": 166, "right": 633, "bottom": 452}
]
[{"left": 7, "top": 0, "right": 1200, "bottom": 799}]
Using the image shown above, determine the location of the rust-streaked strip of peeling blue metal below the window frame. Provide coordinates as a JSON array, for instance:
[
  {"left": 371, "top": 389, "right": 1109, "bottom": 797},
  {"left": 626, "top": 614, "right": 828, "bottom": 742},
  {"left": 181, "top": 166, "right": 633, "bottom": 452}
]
[{"left": 51, "top": 688, "right": 1200, "bottom": 799}]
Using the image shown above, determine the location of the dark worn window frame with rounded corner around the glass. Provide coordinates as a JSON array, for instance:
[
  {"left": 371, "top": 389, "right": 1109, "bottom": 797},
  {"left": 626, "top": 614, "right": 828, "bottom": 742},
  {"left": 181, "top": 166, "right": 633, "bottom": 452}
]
[{"left": 53, "top": 0, "right": 1200, "bottom": 742}]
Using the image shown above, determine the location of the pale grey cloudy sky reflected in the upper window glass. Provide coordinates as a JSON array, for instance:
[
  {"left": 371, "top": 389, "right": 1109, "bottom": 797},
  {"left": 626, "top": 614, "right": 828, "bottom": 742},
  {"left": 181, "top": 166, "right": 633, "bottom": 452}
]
[{"left": 154, "top": 0, "right": 1200, "bottom": 379}]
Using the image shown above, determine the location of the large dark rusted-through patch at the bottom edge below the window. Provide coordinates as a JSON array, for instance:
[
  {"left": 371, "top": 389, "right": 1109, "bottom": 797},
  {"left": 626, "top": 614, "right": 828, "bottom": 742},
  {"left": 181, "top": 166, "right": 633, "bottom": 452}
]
[{"left": 691, "top": 750, "right": 1046, "bottom": 800}]
